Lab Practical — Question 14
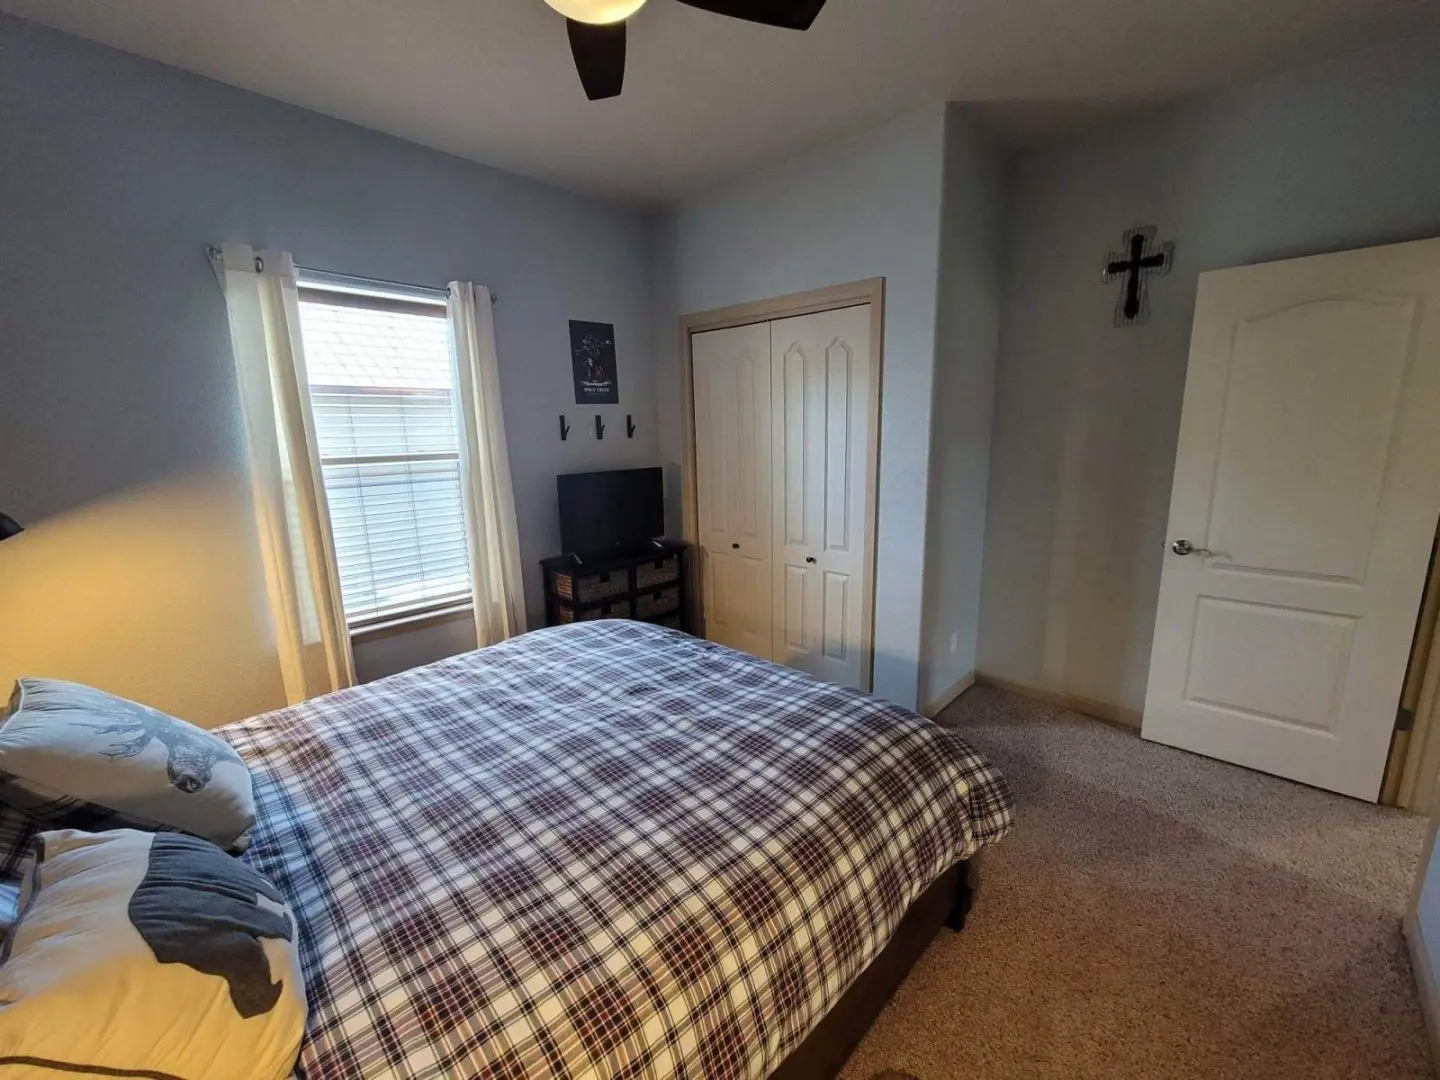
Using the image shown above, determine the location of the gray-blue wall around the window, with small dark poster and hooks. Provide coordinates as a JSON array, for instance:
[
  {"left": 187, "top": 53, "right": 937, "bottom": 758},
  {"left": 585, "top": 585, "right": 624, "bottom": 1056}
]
[{"left": 0, "top": 16, "right": 658, "bottom": 723}]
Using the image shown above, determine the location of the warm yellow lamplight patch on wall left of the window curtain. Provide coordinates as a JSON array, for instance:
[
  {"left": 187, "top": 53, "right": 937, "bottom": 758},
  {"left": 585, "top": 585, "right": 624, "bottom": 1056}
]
[{"left": 0, "top": 471, "right": 285, "bottom": 727}]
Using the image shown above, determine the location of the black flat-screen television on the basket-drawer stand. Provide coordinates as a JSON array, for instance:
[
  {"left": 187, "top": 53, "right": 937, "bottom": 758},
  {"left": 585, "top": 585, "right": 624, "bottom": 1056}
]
[{"left": 556, "top": 468, "right": 665, "bottom": 554}]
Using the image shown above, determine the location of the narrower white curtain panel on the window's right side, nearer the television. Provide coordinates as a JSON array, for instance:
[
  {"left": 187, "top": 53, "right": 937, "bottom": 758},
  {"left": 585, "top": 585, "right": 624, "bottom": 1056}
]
[{"left": 449, "top": 281, "right": 526, "bottom": 647}]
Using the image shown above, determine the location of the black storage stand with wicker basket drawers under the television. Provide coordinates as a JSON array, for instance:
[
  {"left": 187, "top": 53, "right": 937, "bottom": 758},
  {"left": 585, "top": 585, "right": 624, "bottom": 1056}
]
[{"left": 540, "top": 540, "right": 690, "bottom": 634}]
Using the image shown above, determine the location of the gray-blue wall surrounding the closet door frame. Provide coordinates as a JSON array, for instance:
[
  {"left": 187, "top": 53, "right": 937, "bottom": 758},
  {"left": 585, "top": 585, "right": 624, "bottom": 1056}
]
[{"left": 655, "top": 105, "right": 945, "bottom": 706}]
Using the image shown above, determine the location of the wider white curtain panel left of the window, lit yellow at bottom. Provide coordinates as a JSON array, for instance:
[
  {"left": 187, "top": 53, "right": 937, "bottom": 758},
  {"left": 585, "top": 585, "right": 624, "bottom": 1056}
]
[{"left": 212, "top": 245, "right": 356, "bottom": 704}]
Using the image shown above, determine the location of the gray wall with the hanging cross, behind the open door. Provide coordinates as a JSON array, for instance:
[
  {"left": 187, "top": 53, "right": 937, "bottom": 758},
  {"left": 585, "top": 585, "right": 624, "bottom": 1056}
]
[{"left": 979, "top": 37, "right": 1440, "bottom": 719}]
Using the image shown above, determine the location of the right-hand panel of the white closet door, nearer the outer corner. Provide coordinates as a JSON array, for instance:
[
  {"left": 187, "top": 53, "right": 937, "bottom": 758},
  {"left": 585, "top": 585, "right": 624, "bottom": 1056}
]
[{"left": 770, "top": 304, "right": 873, "bottom": 688}]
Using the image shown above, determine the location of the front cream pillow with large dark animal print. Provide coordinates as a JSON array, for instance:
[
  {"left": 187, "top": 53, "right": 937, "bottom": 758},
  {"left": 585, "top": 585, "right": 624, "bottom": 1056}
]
[{"left": 0, "top": 829, "right": 305, "bottom": 1080}]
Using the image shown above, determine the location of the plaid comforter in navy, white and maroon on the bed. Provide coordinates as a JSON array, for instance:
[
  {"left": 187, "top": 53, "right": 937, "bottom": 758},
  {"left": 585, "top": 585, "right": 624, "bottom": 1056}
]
[{"left": 220, "top": 622, "right": 1011, "bottom": 1080}]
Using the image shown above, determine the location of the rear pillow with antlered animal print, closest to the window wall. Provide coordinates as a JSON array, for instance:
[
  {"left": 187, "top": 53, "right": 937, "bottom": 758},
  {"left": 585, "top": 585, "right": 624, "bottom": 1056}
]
[{"left": 0, "top": 678, "right": 255, "bottom": 851}]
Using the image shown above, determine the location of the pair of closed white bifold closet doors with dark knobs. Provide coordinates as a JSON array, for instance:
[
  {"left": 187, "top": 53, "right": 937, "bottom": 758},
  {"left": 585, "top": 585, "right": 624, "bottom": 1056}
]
[{"left": 691, "top": 304, "right": 874, "bottom": 687}]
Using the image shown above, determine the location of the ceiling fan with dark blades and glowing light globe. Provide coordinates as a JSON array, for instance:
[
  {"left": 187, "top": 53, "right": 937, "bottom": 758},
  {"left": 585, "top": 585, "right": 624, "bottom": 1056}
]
[{"left": 544, "top": 0, "right": 825, "bottom": 101}]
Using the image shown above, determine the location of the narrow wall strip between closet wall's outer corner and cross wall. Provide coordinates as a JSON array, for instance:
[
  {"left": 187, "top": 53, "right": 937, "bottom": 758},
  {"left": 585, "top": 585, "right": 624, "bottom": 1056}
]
[{"left": 920, "top": 104, "right": 1005, "bottom": 720}]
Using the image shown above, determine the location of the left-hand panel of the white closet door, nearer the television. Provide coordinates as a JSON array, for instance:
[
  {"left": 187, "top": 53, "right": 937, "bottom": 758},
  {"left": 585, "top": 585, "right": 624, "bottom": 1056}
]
[{"left": 691, "top": 323, "right": 773, "bottom": 660}]
